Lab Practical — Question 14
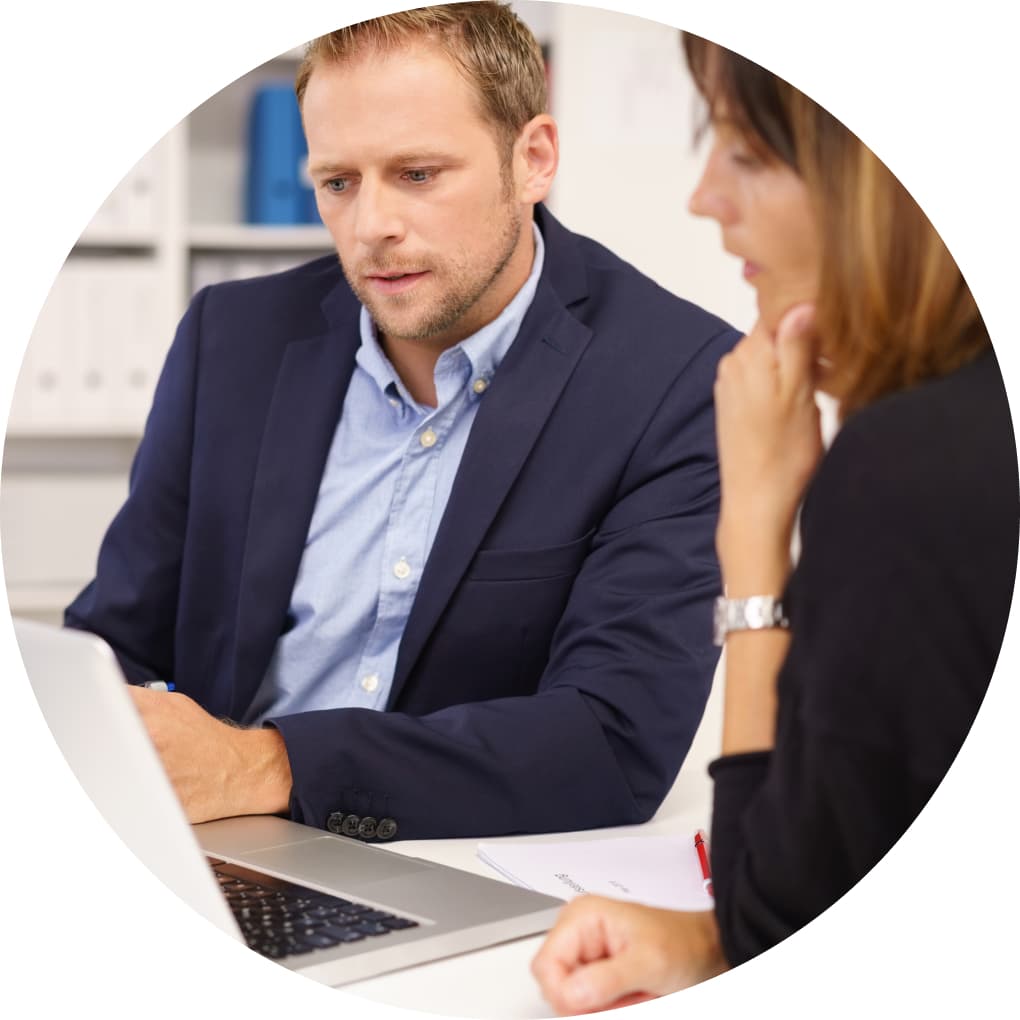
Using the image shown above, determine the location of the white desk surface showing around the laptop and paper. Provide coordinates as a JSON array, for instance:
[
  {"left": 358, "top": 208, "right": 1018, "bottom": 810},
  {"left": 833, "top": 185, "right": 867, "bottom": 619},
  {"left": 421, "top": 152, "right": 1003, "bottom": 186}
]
[{"left": 344, "top": 781, "right": 708, "bottom": 1020}]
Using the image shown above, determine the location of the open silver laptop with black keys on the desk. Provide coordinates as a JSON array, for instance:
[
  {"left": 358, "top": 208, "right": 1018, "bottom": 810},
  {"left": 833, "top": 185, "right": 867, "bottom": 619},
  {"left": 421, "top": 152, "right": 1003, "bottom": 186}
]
[{"left": 14, "top": 619, "right": 563, "bottom": 985}]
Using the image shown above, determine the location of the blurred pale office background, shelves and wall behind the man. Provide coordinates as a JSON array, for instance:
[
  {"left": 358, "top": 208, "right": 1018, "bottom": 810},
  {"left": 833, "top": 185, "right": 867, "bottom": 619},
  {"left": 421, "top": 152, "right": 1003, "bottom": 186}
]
[{"left": 0, "top": 2, "right": 754, "bottom": 621}]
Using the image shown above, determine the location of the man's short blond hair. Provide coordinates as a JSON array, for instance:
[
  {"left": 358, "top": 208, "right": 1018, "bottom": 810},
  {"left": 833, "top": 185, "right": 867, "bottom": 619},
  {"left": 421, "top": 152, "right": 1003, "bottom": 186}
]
[{"left": 295, "top": 2, "right": 548, "bottom": 161}]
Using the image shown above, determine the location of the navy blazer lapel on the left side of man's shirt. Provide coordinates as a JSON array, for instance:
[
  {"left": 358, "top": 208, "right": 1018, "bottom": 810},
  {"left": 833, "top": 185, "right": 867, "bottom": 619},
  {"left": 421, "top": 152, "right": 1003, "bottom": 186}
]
[{"left": 232, "top": 293, "right": 360, "bottom": 715}]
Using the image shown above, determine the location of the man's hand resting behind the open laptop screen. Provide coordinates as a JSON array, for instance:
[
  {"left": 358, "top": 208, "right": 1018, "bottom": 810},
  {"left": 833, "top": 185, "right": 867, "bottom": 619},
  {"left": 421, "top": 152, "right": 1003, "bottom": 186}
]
[{"left": 129, "top": 686, "right": 292, "bottom": 822}]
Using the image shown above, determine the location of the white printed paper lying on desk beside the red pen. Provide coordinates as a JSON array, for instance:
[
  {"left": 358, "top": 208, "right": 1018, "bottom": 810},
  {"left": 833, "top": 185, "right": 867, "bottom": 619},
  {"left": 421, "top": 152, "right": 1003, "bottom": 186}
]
[{"left": 477, "top": 833, "right": 714, "bottom": 910}]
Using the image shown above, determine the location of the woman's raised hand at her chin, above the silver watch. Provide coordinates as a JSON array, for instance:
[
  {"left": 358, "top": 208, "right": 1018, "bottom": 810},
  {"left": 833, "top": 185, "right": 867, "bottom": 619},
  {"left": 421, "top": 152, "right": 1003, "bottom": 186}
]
[{"left": 715, "top": 297, "right": 822, "bottom": 598}]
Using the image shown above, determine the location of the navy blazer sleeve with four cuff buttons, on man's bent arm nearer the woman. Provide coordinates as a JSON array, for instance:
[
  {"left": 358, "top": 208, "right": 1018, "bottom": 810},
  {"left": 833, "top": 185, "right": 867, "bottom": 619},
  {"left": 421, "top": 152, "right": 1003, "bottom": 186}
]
[{"left": 271, "top": 328, "right": 737, "bottom": 838}]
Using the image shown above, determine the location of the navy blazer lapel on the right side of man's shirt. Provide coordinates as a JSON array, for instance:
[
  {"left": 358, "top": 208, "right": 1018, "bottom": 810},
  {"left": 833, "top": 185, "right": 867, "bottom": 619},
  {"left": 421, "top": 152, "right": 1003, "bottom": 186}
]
[{"left": 389, "top": 274, "right": 592, "bottom": 706}]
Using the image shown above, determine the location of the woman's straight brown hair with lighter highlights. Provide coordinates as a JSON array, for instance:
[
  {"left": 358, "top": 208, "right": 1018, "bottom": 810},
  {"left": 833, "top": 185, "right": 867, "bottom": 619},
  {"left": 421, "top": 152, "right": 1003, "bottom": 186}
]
[{"left": 683, "top": 34, "right": 989, "bottom": 417}]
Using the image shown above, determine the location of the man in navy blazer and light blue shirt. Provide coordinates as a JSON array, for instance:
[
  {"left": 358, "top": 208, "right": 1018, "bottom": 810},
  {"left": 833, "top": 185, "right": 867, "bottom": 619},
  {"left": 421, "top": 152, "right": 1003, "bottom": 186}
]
[{"left": 66, "top": 3, "right": 737, "bottom": 839}]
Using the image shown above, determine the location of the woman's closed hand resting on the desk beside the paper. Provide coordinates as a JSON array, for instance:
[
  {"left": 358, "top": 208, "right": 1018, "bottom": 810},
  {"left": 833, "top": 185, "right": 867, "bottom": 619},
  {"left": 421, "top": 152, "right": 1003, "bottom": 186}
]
[{"left": 531, "top": 896, "right": 726, "bottom": 1016}]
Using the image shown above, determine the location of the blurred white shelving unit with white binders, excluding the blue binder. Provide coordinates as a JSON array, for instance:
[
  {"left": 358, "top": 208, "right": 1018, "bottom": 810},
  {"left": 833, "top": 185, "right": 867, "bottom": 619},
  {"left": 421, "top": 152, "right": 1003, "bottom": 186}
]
[{"left": 0, "top": 45, "right": 333, "bottom": 620}]
